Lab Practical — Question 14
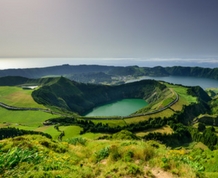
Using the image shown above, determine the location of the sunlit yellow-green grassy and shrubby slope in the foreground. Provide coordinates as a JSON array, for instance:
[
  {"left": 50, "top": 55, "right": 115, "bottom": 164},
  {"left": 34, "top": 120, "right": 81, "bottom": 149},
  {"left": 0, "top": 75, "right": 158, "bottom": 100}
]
[{"left": 0, "top": 134, "right": 208, "bottom": 178}]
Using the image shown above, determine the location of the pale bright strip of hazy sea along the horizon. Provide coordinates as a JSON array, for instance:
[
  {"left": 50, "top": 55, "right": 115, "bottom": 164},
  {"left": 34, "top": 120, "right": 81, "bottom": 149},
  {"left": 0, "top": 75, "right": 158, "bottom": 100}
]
[{"left": 0, "top": 58, "right": 218, "bottom": 69}]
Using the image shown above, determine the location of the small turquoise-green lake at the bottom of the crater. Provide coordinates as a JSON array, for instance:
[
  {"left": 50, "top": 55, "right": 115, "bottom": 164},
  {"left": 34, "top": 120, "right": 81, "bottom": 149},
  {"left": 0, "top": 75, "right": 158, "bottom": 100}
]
[{"left": 86, "top": 99, "right": 148, "bottom": 116}]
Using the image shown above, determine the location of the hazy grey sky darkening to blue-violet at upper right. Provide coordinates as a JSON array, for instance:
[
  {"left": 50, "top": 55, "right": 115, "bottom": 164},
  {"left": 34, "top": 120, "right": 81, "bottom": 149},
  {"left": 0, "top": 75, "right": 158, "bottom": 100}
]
[{"left": 0, "top": 0, "right": 218, "bottom": 67}]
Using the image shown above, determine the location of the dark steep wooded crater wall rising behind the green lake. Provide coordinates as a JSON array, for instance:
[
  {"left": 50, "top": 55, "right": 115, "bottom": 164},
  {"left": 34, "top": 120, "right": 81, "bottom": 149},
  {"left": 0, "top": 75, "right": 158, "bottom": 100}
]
[{"left": 32, "top": 77, "right": 166, "bottom": 114}]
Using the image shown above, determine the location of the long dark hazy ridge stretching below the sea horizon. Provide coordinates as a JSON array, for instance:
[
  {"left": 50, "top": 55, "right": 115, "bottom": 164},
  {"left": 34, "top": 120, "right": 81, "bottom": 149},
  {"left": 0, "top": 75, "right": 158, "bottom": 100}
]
[{"left": 0, "top": 64, "right": 218, "bottom": 80}]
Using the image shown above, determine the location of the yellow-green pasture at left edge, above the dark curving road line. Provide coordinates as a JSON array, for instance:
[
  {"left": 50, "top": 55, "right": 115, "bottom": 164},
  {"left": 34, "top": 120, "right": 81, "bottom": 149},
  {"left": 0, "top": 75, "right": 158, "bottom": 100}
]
[{"left": 0, "top": 86, "right": 45, "bottom": 108}]
